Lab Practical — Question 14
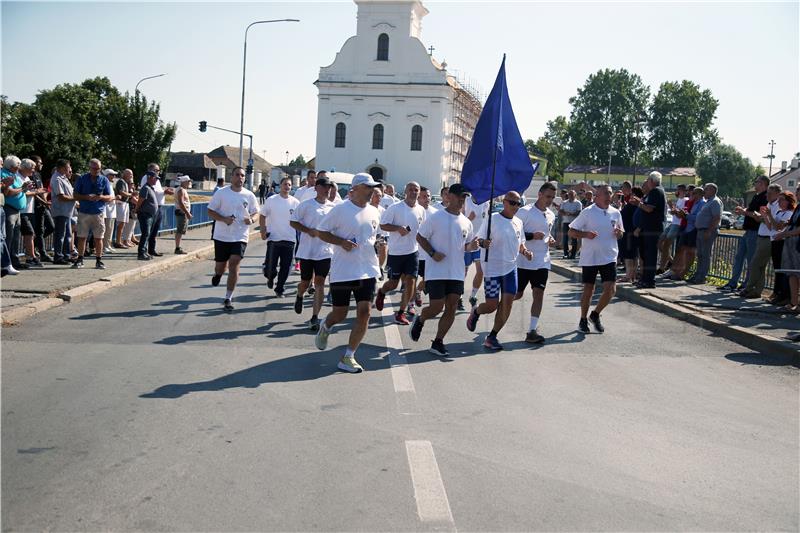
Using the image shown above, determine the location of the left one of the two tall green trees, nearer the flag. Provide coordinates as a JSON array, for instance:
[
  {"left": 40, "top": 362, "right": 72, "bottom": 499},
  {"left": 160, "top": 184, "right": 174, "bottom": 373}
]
[{"left": 568, "top": 69, "right": 650, "bottom": 165}]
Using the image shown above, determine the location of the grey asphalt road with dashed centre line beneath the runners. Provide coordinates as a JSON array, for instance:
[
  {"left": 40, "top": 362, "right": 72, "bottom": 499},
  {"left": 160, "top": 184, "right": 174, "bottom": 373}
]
[{"left": 2, "top": 239, "right": 800, "bottom": 531}]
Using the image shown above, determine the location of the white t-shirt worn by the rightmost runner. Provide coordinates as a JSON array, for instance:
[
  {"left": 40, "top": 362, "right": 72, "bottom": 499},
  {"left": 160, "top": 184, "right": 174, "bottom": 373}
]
[{"left": 569, "top": 204, "right": 623, "bottom": 266}]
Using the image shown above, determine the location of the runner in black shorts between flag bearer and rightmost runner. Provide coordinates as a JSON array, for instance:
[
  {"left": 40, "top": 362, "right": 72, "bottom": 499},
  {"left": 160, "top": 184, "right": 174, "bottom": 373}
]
[{"left": 515, "top": 181, "right": 556, "bottom": 344}]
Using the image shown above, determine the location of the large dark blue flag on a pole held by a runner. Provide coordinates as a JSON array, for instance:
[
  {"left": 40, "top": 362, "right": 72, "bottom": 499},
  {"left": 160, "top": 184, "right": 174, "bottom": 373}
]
[{"left": 461, "top": 54, "right": 535, "bottom": 204}]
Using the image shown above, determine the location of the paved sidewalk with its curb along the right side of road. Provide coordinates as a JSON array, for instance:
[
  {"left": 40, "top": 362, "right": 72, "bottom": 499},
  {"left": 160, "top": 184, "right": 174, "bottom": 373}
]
[{"left": 553, "top": 259, "right": 800, "bottom": 357}]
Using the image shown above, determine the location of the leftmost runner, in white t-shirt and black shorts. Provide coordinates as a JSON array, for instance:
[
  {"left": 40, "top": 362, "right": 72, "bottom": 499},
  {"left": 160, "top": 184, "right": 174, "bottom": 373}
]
[{"left": 208, "top": 167, "right": 258, "bottom": 311}]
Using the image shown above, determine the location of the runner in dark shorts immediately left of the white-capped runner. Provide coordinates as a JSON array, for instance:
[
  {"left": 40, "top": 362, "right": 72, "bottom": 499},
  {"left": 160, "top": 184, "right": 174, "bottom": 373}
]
[{"left": 290, "top": 177, "right": 333, "bottom": 331}]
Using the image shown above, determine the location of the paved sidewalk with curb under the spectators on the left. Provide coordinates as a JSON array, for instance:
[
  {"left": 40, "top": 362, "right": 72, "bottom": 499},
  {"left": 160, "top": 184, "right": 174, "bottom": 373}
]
[{"left": 0, "top": 224, "right": 220, "bottom": 325}]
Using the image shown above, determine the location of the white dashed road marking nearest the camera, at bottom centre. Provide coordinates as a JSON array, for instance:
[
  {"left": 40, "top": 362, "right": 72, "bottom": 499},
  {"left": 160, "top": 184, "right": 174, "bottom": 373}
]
[{"left": 406, "top": 440, "right": 454, "bottom": 524}]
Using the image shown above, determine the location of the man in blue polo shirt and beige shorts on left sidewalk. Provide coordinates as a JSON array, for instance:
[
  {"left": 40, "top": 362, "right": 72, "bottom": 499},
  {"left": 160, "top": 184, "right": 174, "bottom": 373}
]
[{"left": 72, "top": 159, "right": 114, "bottom": 270}]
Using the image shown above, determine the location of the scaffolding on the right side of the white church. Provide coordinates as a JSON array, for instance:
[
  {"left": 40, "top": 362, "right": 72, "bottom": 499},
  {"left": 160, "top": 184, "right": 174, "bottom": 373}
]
[{"left": 447, "top": 75, "right": 483, "bottom": 185}]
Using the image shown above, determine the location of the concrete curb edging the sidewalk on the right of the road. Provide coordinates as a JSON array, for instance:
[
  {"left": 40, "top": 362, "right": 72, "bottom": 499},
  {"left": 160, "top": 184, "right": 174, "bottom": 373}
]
[{"left": 551, "top": 263, "right": 800, "bottom": 358}]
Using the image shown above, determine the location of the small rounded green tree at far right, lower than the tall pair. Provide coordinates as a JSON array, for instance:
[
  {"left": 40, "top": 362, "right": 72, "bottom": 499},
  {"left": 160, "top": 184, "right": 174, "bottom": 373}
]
[{"left": 697, "top": 144, "right": 756, "bottom": 196}]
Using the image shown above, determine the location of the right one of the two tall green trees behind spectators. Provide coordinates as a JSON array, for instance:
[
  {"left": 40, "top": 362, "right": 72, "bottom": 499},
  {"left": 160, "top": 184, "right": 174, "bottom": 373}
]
[{"left": 647, "top": 80, "right": 719, "bottom": 167}]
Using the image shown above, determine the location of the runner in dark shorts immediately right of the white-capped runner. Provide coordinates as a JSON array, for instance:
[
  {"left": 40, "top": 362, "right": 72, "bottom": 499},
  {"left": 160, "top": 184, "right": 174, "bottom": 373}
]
[{"left": 375, "top": 181, "right": 425, "bottom": 326}]
